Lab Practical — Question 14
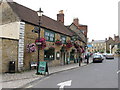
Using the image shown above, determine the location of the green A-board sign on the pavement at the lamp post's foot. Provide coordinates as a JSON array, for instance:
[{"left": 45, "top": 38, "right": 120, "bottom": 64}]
[{"left": 38, "top": 61, "right": 48, "bottom": 74}]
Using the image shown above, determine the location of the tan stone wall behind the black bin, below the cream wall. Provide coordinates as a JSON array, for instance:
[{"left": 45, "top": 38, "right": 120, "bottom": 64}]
[{"left": 2, "top": 39, "right": 18, "bottom": 72}]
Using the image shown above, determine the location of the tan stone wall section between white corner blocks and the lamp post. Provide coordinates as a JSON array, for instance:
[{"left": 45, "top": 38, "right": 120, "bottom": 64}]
[{"left": 24, "top": 23, "right": 37, "bottom": 69}]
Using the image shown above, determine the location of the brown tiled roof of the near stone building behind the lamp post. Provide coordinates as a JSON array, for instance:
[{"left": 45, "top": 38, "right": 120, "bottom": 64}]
[{"left": 8, "top": 2, "right": 73, "bottom": 36}]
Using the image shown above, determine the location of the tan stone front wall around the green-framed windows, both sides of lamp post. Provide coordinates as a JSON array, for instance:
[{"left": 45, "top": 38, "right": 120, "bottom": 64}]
[{"left": 24, "top": 23, "right": 72, "bottom": 69}]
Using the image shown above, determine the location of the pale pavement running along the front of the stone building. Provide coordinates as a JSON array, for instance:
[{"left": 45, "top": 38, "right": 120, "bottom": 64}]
[{"left": 0, "top": 59, "right": 92, "bottom": 88}]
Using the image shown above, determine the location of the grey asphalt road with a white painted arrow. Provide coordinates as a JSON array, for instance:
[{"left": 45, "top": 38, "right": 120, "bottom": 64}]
[{"left": 27, "top": 58, "right": 118, "bottom": 88}]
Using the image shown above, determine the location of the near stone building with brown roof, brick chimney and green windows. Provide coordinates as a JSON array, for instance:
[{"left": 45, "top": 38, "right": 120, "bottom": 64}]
[{"left": 0, "top": 2, "right": 87, "bottom": 72}]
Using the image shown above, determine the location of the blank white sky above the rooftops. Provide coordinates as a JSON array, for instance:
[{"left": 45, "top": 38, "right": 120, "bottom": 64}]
[{"left": 13, "top": 0, "right": 120, "bottom": 41}]
